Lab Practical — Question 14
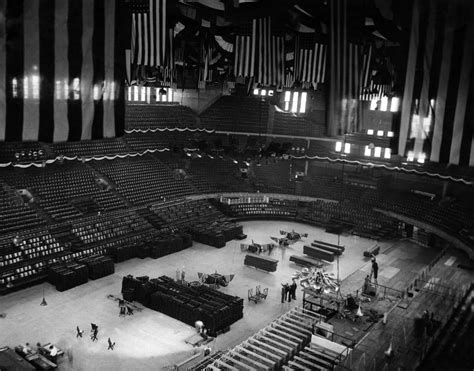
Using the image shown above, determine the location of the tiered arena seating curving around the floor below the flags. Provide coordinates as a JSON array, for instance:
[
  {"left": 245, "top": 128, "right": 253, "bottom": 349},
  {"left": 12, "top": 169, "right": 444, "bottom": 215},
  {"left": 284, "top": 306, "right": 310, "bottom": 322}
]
[{"left": 0, "top": 101, "right": 474, "bottom": 292}]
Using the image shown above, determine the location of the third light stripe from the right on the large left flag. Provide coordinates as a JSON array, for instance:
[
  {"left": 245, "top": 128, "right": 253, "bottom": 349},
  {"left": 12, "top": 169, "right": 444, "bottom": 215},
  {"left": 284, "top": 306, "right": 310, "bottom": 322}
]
[{"left": 53, "top": 0, "right": 69, "bottom": 142}]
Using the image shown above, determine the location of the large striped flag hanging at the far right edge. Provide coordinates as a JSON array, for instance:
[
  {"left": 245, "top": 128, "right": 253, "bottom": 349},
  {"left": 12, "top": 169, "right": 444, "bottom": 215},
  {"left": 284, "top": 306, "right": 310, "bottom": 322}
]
[{"left": 398, "top": 1, "right": 474, "bottom": 166}]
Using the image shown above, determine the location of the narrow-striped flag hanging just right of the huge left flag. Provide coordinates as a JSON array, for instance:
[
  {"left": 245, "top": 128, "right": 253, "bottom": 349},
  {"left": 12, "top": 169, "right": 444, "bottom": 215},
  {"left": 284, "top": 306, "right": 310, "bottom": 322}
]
[{"left": 130, "top": 0, "right": 168, "bottom": 67}]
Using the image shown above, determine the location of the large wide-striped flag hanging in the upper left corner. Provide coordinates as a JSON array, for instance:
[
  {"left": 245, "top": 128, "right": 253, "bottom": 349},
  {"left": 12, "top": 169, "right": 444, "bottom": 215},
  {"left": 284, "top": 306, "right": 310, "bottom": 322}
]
[{"left": 0, "top": 0, "right": 125, "bottom": 142}]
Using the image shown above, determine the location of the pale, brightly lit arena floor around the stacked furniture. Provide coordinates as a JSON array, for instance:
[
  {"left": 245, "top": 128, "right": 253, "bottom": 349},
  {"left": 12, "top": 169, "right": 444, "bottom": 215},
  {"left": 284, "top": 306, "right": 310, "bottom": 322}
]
[{"left": 0, "top": 221, "right": 392, "bottom": 371}]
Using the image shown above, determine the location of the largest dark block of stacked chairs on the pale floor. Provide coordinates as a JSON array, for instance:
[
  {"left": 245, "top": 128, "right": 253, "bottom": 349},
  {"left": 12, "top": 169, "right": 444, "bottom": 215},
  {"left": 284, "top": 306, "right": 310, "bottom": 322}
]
[{"left": 122, "top": 276, "right": 243, "bottom": 336}]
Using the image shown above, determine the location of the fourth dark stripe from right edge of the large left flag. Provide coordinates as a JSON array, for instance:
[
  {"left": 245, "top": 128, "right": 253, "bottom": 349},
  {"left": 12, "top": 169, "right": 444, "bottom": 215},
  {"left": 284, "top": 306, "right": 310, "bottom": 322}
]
[{"left": 35, "top": 0, "right": 54, "bottom": 142}]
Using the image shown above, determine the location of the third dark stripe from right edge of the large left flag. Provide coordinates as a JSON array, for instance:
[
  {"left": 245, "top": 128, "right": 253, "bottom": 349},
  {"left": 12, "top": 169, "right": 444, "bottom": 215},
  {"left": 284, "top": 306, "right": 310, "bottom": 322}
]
[{"left": 67, "top": 0, "right": 83, "bottom": 141}]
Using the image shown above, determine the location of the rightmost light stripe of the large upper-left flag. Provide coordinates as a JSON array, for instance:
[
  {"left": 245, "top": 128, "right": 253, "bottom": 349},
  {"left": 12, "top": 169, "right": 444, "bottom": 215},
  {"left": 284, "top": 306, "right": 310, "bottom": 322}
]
[{"left": 102, "top": 0, "right": 115, "bottom": 138}]
